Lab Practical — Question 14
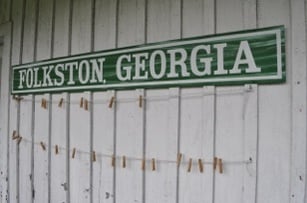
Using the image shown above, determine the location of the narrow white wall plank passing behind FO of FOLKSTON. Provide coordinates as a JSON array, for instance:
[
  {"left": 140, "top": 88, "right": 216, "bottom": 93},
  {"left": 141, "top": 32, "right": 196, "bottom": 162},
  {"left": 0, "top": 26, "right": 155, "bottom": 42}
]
[{"left": 19, "top": 1, "right": 37, "bottom": 202}]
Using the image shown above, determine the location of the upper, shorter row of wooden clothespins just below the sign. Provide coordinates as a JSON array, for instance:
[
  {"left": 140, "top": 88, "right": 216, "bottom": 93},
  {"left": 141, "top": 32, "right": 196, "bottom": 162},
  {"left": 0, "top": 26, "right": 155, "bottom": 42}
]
[{"left": 13, "top": 95, "right": 144, "bottom": 110}]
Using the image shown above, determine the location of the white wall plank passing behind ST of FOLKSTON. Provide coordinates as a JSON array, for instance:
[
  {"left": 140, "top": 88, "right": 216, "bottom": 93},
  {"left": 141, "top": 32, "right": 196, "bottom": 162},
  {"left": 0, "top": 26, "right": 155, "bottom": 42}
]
[{"left": 50, "top": 0, "right": 70, "bottom": 203}]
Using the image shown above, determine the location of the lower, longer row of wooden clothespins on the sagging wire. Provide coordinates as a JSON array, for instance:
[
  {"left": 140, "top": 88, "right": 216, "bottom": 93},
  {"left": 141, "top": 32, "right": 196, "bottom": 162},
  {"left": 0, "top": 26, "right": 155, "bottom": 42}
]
[{"left": 12, "top": 131, "right": 223, "bottom": 173}]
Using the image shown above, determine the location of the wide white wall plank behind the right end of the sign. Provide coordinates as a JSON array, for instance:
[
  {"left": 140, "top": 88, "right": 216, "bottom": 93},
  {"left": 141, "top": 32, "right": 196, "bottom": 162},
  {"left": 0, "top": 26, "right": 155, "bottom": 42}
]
[{"left": 257, "top": 0, "right": 294, "bottom": 203}]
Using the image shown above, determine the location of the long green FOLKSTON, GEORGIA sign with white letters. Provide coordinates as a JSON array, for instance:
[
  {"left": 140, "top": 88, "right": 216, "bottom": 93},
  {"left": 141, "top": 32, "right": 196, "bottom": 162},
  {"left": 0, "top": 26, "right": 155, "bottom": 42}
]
[{"left": 12, "top": 26, "right": 286, "bottom": 94}]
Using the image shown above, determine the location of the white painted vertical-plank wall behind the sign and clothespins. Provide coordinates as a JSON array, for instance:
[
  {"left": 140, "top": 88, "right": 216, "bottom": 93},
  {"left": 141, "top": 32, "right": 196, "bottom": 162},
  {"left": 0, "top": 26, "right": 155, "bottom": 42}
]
[{"left": 0, "top": 0, "right": 307, "bottom": 203}]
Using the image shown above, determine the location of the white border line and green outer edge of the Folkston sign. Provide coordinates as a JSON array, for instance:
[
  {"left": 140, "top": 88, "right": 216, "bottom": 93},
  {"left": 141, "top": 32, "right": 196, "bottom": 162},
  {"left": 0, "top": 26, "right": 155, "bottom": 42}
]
[{"left": 11, "top": 26, "right": 286, "bottom": 94}]
